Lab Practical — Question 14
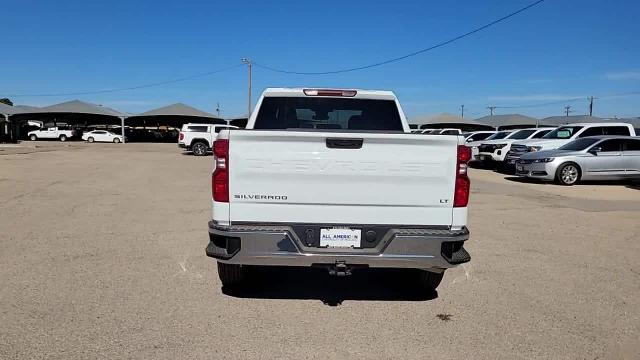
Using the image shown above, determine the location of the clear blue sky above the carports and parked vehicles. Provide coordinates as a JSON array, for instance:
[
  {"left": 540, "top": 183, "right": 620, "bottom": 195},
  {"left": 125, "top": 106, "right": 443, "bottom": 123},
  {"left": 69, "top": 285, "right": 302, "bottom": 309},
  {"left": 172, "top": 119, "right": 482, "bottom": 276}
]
[{"left": 0, "top": 0, "right": 640, "bottom": 117}]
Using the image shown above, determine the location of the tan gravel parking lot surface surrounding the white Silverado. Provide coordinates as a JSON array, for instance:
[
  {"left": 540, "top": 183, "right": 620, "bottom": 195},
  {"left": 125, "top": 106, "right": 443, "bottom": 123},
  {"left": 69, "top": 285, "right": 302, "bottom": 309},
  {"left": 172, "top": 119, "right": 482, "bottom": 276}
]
[{"left": 0, "top": 143, "right": 640, "bottom": 359}]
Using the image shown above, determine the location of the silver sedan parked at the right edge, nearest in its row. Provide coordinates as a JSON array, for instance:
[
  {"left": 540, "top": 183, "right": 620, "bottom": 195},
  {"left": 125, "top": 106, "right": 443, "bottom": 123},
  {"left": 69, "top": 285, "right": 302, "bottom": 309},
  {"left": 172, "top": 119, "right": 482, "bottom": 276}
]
[{"left": 516, "top": 136, "right": 640, "bottom": 185}]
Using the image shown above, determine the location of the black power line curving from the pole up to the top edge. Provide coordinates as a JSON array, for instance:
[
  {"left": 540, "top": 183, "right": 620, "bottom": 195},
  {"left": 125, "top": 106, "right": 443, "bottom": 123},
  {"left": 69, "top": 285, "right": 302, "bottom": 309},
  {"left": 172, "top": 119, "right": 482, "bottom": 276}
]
[{"left": 253, "top": 0, "right": 545, "bottom": 75}]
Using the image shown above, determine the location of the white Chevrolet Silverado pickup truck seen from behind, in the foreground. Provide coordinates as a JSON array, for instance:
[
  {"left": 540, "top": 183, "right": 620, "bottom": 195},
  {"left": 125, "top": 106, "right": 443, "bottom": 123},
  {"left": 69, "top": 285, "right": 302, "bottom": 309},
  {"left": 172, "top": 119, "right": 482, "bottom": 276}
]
[{"left": 206, "top": 88, "right": 471, "bottom": 289}]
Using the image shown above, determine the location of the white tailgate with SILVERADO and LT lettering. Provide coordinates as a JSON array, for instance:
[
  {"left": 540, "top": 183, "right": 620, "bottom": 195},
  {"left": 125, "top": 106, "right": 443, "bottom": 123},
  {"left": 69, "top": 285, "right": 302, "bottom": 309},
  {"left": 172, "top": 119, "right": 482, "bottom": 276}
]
[{"left": 229, "top": 130, "right": 458, "bottom": 225}]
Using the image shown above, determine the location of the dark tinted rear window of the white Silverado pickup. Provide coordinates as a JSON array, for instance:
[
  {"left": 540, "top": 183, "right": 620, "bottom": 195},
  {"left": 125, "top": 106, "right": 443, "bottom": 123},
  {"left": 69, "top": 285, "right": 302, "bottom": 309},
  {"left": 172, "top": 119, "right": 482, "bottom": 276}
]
[{"left": 253, "top": 97, "right": 404, "bottom": 131}]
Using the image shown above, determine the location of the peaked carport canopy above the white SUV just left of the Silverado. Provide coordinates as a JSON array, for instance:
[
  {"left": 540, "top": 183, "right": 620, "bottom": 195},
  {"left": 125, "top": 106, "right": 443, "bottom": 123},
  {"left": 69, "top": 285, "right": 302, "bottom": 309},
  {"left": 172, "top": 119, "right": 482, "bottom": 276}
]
[{"left": 127, "top": 103, "right": 227, "bottom": 128}]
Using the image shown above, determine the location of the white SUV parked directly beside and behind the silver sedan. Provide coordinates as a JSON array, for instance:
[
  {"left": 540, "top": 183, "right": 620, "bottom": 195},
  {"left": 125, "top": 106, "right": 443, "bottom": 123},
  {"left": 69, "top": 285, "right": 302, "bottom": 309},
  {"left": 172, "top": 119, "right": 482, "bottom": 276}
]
[{"left": 506, "top": 122, "right": 636, "bottom": 164}]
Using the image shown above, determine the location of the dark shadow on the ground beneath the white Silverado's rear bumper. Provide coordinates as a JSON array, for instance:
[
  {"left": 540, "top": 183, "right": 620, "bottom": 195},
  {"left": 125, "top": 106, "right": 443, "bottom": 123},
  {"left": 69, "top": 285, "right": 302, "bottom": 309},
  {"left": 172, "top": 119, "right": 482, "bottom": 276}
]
[{"left": 222, "top": 267, "right": 438, "bottom": 306}]
